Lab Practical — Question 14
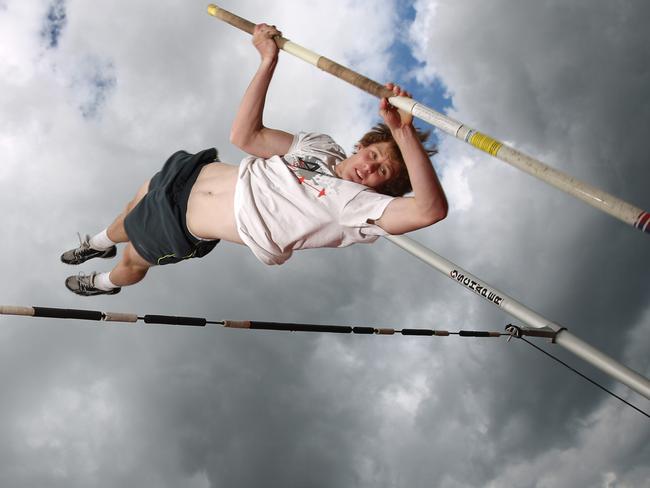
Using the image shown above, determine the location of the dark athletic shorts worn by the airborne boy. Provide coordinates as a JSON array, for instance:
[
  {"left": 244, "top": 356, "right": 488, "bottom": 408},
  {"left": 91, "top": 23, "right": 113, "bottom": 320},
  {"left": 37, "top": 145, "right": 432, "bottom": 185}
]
[{"left": 124, "top": 149, "right": 219, "bottom": 265}]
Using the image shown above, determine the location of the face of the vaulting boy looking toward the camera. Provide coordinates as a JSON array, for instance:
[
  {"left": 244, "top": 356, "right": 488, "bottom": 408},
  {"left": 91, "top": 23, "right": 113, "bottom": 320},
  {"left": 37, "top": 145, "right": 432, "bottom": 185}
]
[{"left": 336, "top": 142, "right": 400, "bottom": 189}]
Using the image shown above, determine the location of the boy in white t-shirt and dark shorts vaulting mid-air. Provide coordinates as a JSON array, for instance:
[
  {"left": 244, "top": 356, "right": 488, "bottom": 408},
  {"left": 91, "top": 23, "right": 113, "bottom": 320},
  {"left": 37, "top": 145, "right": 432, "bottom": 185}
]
[{"left": 61, "top": 24, "right": 447, "bottom": 296}]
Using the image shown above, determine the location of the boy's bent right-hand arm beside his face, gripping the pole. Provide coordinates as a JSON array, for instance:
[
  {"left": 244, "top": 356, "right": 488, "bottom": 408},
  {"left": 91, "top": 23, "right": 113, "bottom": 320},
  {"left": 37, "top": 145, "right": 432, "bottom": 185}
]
[{"left": 375, "top": 83, "right": 448, "bottom": 234}]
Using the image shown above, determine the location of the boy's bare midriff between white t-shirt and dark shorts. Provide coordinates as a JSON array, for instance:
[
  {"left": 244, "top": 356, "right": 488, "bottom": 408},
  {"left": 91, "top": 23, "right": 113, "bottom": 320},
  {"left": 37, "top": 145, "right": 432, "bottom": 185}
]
[{"left": 186, "top": 163, "right": 242, "bottom": 244}]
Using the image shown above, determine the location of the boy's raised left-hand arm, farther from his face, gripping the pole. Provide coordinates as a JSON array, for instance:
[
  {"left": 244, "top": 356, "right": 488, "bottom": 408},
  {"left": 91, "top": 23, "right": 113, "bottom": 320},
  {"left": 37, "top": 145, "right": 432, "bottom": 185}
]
[{"left": 230, "top": 24, "right": 293, "bottom": 158}]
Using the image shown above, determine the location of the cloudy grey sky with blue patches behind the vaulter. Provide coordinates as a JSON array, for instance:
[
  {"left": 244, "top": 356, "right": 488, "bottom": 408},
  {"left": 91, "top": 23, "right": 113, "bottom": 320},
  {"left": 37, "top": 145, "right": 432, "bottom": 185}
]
[{"left": 0, "top": 0, "right": 650, "bottom": 488}]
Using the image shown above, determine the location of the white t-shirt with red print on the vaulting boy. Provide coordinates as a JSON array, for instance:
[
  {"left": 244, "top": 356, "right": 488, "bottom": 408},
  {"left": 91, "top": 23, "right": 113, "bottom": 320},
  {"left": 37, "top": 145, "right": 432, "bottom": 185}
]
[{"left": 235, "top": 132, "right": 394, "bottom": 264}]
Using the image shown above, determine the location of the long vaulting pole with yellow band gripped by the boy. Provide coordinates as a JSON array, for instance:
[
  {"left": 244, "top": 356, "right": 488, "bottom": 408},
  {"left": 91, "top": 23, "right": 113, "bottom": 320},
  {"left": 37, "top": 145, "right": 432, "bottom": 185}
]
[{"left": 208, "top": 4, "right": 650, "bottom": 233}]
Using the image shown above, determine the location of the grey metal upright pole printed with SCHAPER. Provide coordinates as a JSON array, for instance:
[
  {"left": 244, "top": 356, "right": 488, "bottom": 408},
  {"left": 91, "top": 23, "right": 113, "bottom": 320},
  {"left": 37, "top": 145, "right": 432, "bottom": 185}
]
[{"left": 386, "top": 236, "right": 650, "bottom": 400}]
